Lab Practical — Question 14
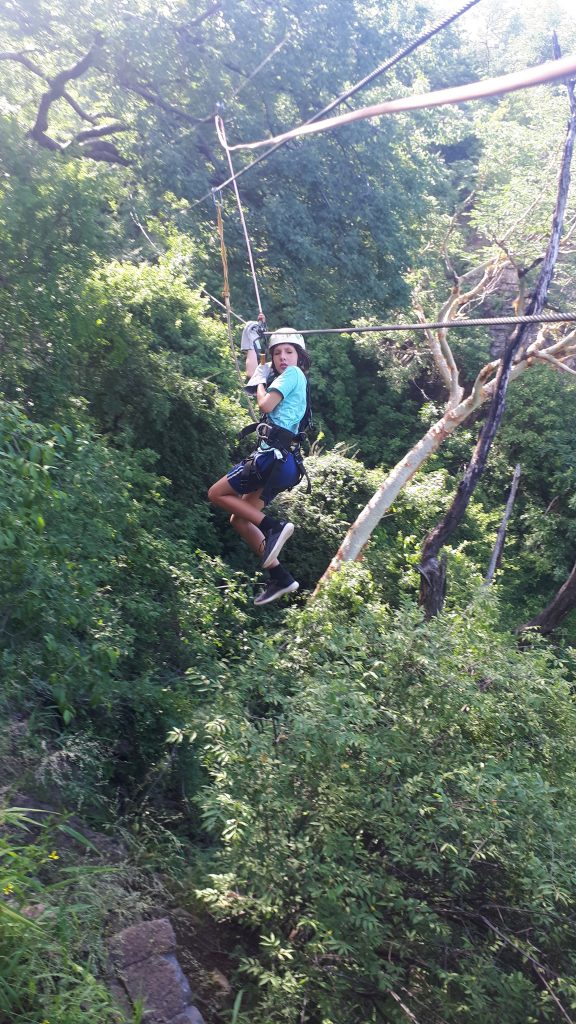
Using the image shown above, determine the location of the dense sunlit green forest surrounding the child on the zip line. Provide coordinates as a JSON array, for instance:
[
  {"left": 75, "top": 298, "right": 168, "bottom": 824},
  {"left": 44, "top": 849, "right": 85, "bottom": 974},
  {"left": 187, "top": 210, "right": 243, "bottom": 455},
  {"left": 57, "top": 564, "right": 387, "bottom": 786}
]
[{"left": 0, "top": 0, "right": 576, "bottom": 1024}]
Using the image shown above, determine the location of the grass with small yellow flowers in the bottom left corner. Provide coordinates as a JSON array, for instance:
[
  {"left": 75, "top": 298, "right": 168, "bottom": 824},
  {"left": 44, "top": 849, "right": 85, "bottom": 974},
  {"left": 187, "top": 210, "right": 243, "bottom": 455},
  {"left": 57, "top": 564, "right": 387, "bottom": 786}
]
[{"left": 0, "top": 808, "right": 122, "bottom": 1024}]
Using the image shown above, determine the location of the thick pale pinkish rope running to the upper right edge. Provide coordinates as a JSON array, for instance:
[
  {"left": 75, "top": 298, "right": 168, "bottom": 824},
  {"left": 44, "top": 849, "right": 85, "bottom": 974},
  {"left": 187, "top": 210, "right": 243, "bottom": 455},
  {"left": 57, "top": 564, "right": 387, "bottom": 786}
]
[{"left": 230, "top": 54, "right": 576, "bottom": 153}]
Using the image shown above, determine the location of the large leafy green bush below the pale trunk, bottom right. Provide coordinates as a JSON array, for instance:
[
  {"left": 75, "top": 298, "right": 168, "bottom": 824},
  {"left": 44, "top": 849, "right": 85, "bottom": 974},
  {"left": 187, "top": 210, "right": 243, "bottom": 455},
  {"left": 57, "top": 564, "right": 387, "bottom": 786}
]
[{"left": 201, "top": 566, "right": 576, "bottom": 1024}]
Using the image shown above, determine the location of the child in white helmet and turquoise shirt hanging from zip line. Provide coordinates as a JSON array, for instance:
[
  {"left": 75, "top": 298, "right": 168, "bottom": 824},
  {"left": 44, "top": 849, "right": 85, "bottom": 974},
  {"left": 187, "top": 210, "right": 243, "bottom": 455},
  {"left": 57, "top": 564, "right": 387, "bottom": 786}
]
[{"left": 208, "top": 328, "right": 310, "bottom": 605}]
